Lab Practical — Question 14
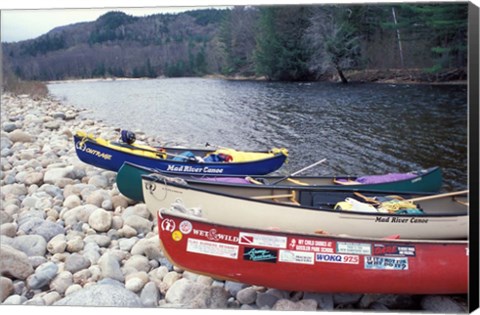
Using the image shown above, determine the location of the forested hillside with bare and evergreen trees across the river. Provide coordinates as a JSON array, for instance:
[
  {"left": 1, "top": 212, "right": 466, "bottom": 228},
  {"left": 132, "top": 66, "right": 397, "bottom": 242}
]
[{"left": 2, "top": 3, "right": 468, "bottom": 82}]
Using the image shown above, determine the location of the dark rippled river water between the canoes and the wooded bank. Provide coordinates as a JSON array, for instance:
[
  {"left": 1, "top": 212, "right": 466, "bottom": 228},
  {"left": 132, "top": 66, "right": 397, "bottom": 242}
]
[{"left": 48, "top": 78, "right": 468, "bottom": 191}]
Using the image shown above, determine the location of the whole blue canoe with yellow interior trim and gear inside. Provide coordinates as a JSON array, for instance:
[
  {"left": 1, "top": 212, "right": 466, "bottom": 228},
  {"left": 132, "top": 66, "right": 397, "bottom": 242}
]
[{"left": 73, "top": 131, "right": 288, "bottom": 175}]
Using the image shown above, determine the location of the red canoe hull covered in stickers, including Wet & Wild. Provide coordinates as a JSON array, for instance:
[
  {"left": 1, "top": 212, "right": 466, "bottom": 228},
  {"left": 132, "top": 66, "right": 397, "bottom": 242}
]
[{"left": 158, "top": 212, "right": 468, "bottom": 294}]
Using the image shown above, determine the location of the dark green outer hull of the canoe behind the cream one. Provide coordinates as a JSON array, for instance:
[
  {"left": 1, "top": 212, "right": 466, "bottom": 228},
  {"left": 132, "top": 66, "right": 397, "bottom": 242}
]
[{"left": 116, "top": 162, "right": 442, "bottom": 201}]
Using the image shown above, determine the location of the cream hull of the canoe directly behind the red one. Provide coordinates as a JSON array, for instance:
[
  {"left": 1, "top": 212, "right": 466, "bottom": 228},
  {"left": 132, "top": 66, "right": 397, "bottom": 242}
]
[{"left": 142, "top": 175, "right": 469, "bottom": 239}]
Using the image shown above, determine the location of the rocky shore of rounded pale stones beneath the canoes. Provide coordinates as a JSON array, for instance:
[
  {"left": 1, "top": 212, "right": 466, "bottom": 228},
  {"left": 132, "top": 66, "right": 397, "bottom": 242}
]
[{"left": 0, "top": 94, "right": 467, "bottom": 313}]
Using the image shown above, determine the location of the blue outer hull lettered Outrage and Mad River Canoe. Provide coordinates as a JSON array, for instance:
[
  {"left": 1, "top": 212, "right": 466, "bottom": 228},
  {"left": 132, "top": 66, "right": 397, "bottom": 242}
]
[{"left": 74, "top": 135, "right": 287, "bottom": 175}]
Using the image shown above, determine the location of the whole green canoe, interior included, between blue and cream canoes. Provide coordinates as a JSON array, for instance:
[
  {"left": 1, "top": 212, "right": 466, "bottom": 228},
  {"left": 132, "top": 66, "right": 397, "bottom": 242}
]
[{"left": 117, "top": 162, "right": 442, "bottom": 202}]
